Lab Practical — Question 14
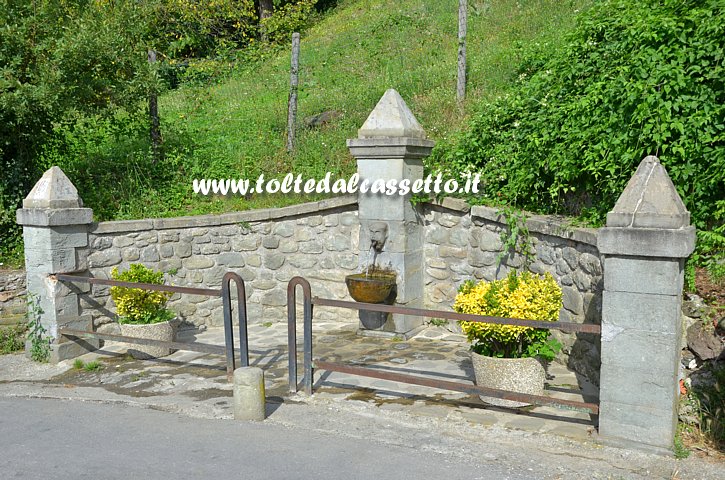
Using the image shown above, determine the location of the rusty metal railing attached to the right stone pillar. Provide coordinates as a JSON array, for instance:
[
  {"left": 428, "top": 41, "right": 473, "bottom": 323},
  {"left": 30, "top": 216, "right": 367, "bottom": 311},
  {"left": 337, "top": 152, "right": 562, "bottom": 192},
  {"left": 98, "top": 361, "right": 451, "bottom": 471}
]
[{"left": 287, "top": 277, "right": 601, "bottom": 415}]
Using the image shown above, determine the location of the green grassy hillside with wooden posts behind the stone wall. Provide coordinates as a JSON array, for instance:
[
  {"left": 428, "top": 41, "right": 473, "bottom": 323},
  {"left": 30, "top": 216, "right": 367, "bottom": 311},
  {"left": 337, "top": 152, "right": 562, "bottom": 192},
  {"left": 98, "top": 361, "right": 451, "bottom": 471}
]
[{"left": 22, "top": 0, "right": 591, "bottom": 232}]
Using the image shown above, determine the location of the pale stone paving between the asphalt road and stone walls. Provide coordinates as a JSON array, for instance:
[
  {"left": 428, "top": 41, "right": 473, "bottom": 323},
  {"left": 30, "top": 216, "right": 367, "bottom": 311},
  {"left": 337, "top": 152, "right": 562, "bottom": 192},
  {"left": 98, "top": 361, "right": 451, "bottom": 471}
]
[{"left": 0, "top": 322, "right": 725, "bottom": 479}]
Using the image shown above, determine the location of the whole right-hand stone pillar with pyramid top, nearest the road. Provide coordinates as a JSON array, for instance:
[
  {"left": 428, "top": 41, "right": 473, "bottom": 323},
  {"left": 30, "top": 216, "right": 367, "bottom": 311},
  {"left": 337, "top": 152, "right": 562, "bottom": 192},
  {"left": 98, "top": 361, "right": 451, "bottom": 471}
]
[{"left": 598, "top": 156, "right": 695, "bottom": 452}]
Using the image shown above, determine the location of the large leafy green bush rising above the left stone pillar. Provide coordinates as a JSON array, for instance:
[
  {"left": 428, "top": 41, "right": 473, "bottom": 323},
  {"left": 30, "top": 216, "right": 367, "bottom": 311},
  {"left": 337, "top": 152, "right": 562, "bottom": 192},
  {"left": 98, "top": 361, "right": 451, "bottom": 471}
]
[{"left": 0, "top": 0, "right": 150, "bottom": 262}]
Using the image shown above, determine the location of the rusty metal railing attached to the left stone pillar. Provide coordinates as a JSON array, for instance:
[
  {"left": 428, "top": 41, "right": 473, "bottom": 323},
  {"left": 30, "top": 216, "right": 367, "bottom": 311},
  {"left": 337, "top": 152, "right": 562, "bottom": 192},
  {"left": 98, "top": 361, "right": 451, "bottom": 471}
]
[{"left": 50, "top": 272, "right": 249, "bottom": 381}]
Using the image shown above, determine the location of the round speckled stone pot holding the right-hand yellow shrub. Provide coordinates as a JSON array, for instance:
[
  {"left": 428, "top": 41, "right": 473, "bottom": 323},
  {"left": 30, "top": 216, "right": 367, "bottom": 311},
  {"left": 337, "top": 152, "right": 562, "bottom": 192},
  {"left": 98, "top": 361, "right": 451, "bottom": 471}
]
[{"left": 471, "top": 352, "right": 546, "bottom": 408}]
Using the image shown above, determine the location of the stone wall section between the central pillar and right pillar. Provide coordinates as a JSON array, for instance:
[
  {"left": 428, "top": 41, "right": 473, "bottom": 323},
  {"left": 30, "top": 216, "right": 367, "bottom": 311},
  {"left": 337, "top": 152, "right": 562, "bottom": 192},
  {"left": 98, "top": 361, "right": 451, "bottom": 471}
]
[{"left": 423, "top": 199, "right": 603, "bottom": 382}]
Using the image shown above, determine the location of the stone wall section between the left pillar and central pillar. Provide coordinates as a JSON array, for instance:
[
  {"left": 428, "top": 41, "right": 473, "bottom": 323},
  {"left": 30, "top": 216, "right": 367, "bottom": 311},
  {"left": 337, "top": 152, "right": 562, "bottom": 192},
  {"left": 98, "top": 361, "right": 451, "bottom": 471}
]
[{"left": 81, "top": 197, "right": 359, "bottom": 331}]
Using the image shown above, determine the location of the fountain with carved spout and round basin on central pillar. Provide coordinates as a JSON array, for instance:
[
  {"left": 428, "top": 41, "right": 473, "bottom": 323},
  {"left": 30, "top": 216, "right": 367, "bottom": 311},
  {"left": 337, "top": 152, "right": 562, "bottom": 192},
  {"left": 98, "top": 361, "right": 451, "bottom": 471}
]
[{"left": 345, "top": 222, "right": 398, "bottom": 330}]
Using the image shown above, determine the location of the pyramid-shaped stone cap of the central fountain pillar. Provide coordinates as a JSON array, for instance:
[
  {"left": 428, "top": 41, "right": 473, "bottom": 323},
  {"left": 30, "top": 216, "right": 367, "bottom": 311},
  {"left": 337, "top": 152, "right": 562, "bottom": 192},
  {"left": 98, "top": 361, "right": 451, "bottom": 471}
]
[{"left": 358, "top": 88, "right": 425, "bottom": 138}]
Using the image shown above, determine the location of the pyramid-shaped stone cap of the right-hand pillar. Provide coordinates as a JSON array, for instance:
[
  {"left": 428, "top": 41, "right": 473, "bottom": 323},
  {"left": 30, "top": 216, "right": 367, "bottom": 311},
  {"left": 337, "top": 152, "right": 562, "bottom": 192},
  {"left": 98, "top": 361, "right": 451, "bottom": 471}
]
[{"left": 607, "top": 155, "right": 690, "bottom": 229}]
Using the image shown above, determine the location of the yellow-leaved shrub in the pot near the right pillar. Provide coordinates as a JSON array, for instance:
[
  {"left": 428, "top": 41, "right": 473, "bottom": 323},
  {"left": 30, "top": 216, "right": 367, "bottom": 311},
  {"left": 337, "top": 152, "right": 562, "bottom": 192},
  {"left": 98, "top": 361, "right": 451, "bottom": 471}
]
[{"left": 453, "top": 271, "right": 562, "bottom": 360}]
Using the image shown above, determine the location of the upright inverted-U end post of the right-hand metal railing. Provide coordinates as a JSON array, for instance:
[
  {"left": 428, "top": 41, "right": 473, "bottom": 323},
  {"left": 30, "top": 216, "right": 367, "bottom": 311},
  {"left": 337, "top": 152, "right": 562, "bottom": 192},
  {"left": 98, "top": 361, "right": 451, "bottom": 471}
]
[{"left": 287, "top": 277, "right": 313, "bottom": 395}]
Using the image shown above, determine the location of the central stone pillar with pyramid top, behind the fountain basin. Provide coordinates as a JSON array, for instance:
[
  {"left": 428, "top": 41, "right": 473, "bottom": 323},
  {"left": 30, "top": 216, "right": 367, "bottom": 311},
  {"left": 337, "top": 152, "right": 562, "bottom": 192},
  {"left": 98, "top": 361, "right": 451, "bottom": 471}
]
[{"left": 347, "top": 89, "right": 435, "bottom": 338}]
